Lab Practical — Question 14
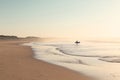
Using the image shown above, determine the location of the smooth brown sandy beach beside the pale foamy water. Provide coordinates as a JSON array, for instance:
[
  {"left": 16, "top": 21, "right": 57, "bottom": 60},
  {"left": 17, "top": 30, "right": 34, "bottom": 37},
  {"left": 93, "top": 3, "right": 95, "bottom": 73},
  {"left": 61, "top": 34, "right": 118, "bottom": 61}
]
[{"left": 0, "top": 40, "right": 90, "bottom": 80}]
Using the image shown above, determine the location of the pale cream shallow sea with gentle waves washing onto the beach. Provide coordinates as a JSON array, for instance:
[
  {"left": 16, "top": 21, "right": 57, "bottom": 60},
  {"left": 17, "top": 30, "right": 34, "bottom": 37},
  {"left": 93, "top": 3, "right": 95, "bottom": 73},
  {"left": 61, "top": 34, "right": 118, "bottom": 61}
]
[{"left": 25, "top": 41, "right": 120, "bottom": 80}]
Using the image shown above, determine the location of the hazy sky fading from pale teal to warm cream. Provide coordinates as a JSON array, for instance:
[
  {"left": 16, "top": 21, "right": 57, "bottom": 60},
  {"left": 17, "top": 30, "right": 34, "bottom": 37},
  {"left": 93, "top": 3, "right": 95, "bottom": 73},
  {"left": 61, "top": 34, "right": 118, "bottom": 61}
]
[{"left": 0, "top": 0, "right": 120, "bottom": 37}]
